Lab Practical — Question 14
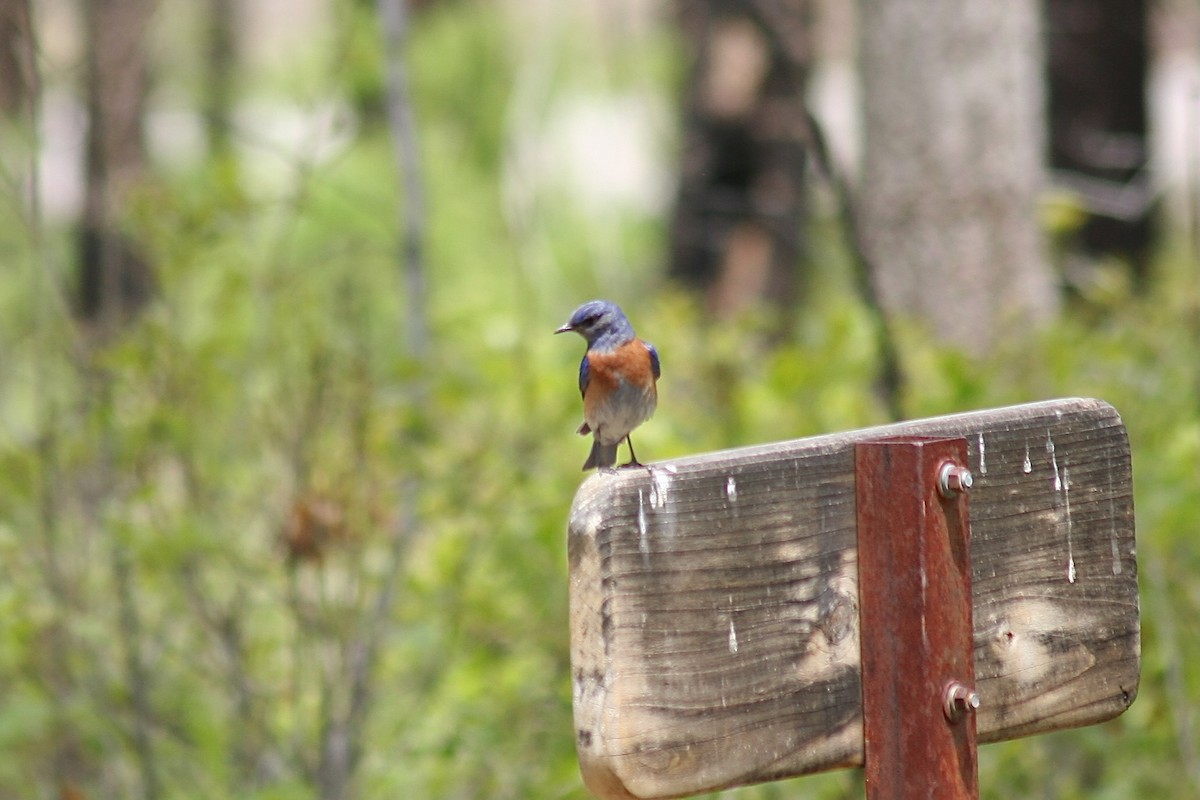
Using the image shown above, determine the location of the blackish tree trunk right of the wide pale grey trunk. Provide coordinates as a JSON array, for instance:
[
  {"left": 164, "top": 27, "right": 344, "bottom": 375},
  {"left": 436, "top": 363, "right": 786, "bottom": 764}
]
[{"left": 1045, "top": 0, "right": 1154, "bottom": 279}]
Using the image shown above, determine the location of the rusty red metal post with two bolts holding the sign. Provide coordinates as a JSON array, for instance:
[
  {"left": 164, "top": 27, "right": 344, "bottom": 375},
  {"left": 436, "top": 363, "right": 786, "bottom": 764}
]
[{"left": 854, "top": 437, "right": 979, "bottom": 800}]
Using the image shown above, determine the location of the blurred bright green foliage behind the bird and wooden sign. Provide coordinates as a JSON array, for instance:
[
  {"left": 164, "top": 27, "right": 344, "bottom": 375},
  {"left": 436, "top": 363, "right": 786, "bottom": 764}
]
[{"left": 0, "top": 2, "right": 1200, "bottom": 800}]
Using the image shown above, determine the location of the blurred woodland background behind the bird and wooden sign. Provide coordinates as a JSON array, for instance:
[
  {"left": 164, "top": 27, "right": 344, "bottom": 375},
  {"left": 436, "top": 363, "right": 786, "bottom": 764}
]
[{"left": 0, "top": 0, "right": 1200, "bottom": 800}]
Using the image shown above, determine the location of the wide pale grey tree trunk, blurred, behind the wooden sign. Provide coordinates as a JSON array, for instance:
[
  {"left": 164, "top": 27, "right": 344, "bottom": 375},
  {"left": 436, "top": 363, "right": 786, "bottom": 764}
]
[{"left": 860, "top": 0, "right": 1057, "bottom": 354}]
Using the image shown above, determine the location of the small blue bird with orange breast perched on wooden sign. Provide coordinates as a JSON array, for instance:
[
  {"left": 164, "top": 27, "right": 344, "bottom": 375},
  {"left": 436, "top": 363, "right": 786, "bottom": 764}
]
[{"left": 554, "top": 300, "right": 662, "bottom": 471}]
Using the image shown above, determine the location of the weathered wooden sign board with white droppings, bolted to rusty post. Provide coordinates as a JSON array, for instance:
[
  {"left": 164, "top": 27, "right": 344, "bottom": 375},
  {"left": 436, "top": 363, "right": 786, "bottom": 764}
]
[{"left": 569, "top": 399, "right": 1140, "bottom": 799}]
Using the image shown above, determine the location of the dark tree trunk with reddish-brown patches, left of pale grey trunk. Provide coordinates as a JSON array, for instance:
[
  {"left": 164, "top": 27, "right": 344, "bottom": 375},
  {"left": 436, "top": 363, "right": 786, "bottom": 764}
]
[{"left": 670, "top": 0, "right": 812, "bottom": 315}]
